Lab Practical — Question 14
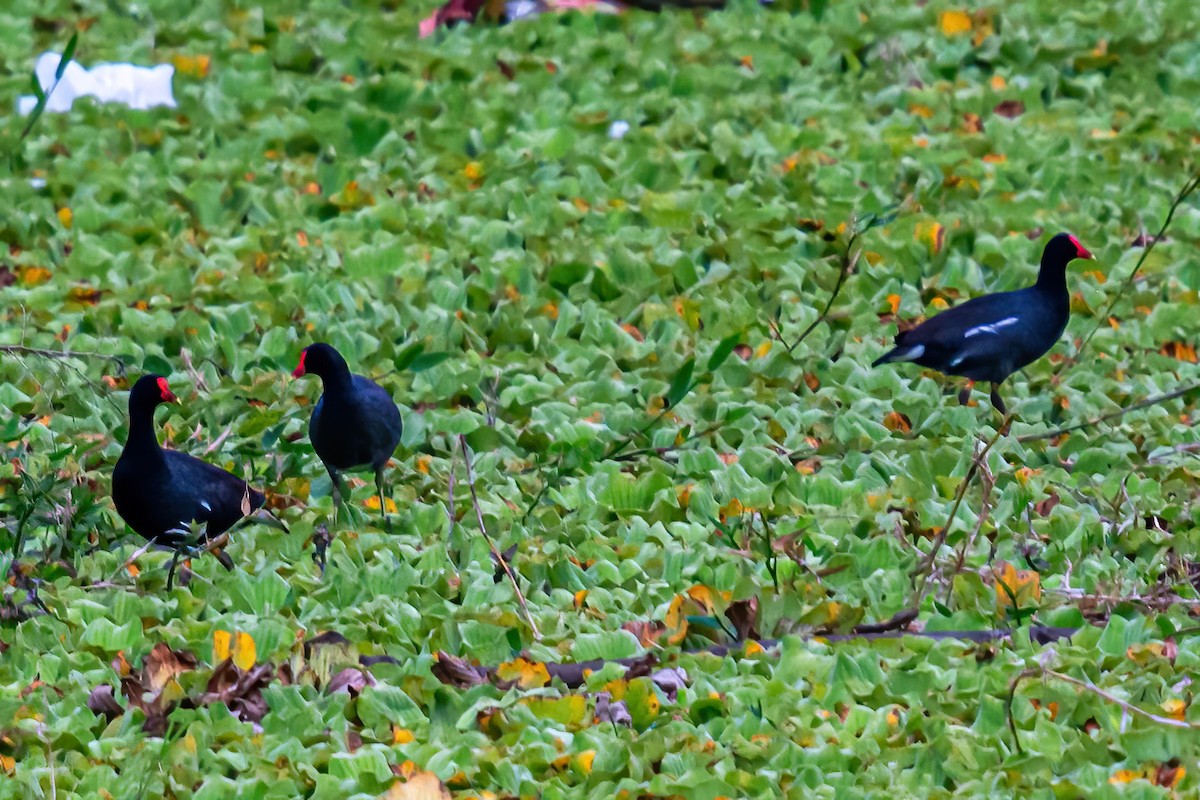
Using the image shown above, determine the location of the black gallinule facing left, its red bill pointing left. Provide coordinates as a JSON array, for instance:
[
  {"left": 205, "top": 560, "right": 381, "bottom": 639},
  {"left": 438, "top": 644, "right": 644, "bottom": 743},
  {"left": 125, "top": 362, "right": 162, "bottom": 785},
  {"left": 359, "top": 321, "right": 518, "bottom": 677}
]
[{"left": 292, "top": 342, "right": 403, "bottom": 534}]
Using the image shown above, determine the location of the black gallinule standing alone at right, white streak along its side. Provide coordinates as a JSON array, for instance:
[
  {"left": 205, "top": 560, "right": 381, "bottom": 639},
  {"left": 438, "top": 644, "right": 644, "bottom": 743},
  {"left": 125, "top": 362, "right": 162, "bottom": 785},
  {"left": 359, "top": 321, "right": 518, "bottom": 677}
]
[{"left": 871, "top": 234, "right": 1092, "bottom": 414}]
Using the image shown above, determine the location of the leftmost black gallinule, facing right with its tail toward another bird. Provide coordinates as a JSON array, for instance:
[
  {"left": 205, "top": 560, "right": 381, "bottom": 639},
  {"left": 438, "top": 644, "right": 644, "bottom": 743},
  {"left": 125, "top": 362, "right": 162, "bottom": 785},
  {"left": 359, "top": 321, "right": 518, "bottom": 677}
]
[{"left": 113, "top": 375, "right": 265, "bottom": 589}]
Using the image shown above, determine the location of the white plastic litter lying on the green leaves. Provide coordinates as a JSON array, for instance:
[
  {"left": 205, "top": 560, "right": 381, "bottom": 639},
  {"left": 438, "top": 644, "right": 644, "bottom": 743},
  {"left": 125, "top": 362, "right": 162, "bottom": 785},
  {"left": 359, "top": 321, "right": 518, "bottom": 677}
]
[{"left": 17, "top": 53, "right": 176, "bottom": 116}]
